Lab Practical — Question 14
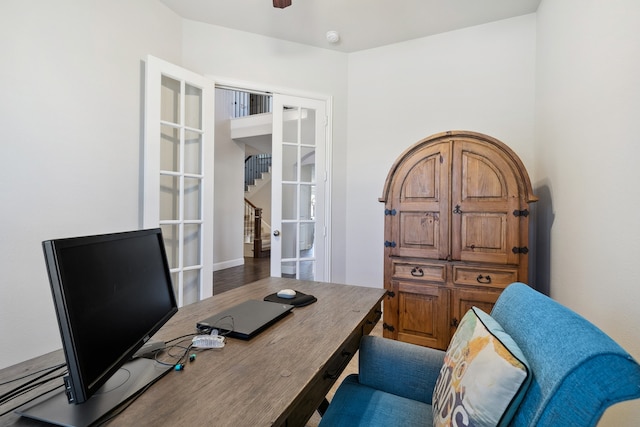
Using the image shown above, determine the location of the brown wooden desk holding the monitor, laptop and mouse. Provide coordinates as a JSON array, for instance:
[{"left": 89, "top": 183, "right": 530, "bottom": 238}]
[{"left": 0, "top": 277, "right": 385, "bottom": 426}]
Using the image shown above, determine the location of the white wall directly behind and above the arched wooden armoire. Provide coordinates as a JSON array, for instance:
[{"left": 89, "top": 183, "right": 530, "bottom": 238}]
[{"left": 346, "top": 15, "right": 535, "bottom": 287}]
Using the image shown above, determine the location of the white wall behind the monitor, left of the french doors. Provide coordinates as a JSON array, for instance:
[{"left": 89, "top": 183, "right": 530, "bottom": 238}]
[{"left": 0, "top": 0, "right": 181, "bottom": 367}]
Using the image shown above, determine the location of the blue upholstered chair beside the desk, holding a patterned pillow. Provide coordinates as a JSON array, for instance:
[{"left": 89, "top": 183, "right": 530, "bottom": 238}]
[{"left": 320, "top": 283, "right": 640, "bottom": 427}]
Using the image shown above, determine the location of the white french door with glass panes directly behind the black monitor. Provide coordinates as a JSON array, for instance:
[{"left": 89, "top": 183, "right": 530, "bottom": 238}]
[{"left": 143, "top": 56, "right": 214, "bottom": 306}]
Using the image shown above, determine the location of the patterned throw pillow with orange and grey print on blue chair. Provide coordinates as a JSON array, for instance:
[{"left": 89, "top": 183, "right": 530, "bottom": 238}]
[{"left": 433, "top": 307, "right": 531, "bottom": 427}]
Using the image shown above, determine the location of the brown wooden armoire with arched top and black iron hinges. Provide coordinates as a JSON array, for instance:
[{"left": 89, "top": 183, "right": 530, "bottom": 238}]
[{"left": 380, "top": 131, "right": 537, "bottom": 349}]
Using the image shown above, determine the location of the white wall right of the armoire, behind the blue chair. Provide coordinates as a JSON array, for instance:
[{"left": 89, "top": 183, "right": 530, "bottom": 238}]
[{"left": 534, "top": 0, "right": 640, "bottom": 426}]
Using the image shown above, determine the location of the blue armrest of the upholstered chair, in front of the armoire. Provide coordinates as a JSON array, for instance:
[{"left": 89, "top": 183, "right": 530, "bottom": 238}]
[{"left": 358, "top": 335, "right": 445, "bottom": 404}]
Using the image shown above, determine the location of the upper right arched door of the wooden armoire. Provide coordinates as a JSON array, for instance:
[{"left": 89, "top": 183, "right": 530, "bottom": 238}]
[{"left": 451, "top": 140, "right": 520, "bottom": 264}]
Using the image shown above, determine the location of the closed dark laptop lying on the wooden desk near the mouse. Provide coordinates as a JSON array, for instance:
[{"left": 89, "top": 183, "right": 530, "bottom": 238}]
[{"left": 196, "top": 300, "right": 294, "bottom": 340}]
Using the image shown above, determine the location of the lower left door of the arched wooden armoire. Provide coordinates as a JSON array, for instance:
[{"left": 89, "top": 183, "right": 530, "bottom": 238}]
[{"left": 398, "top": 282, "right": 449, "bottom": 349}]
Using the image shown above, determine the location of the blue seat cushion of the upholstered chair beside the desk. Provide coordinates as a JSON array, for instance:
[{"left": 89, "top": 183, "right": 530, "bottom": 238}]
[{"left": 320, "top": 374, "right": 432, "bottom": 427}]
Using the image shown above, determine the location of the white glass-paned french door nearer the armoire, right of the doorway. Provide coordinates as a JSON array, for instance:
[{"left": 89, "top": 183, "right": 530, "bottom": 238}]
[{"left": 271, "top": 94, "right": 329, "bottom": 281}]
